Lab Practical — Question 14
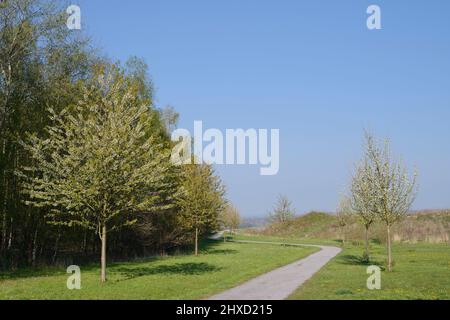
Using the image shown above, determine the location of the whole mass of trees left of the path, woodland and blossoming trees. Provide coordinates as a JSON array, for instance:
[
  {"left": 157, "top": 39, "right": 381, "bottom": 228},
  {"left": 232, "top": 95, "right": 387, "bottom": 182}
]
[{"left": 0, "top": 0, "right": 226, "bottom": 281}]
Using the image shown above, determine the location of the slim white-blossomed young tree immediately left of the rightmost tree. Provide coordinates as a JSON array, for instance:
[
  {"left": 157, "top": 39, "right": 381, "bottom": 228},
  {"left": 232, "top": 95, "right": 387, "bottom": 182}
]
[{"left": 350, "top": 155, "right": 376, "bottom": 262}]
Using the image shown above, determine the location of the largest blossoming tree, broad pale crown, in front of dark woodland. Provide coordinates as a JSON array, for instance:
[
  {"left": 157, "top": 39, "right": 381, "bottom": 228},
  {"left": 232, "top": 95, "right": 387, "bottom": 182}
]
[{"left": 21, "top": 67, "right": 171, "bottom": 282}]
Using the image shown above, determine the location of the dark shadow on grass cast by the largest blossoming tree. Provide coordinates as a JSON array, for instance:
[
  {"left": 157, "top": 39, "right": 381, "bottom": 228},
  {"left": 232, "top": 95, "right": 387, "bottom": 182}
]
[{"left": 115, "top": 262, "right": 222, "bottom": 280}]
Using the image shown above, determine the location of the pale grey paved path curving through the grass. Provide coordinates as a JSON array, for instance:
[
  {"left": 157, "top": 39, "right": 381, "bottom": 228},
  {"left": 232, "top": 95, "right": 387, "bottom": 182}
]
[{"left": 209, "top": 241, "right": 341, "bottom": 300}]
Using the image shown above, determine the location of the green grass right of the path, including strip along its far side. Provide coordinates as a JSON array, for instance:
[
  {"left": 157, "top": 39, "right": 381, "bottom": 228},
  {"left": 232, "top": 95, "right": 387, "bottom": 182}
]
[{"left": 238, "top": 235, "right": 450, "bottom": 300}]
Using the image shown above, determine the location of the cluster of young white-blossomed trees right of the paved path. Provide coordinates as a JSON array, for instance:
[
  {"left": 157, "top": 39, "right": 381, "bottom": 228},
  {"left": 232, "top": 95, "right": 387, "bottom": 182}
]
[{"left": 337, "top": 133, "right": 417, "bottom": 271}]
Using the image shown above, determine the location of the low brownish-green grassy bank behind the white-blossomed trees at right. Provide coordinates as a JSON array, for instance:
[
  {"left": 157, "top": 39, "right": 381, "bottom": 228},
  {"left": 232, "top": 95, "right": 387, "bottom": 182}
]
[{"left": 250, "top": 210, "right": 450, "bottom": 243}]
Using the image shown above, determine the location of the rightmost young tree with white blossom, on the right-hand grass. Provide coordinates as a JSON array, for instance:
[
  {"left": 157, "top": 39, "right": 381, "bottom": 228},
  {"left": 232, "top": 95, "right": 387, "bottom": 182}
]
[{"left": 366, "top": 133, "right": 417, "bottom": 271}]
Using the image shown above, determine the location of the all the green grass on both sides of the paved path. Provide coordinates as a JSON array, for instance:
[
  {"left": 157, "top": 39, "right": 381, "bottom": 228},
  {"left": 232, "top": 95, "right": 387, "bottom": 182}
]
[{"left": 0, "top": 235, "right": 450, "bottom": 300}]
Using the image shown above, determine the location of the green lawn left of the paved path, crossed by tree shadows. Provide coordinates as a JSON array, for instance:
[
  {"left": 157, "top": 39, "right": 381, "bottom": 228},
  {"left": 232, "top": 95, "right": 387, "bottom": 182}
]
[{"left": 0, "top": 242, "right": 315, "bottom": 299}]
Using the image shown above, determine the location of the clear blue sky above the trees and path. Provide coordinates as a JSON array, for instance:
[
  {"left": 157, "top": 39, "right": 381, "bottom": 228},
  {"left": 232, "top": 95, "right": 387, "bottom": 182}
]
[{"left": 77, "top": 0, "right": 450, "bottom": 216}]
